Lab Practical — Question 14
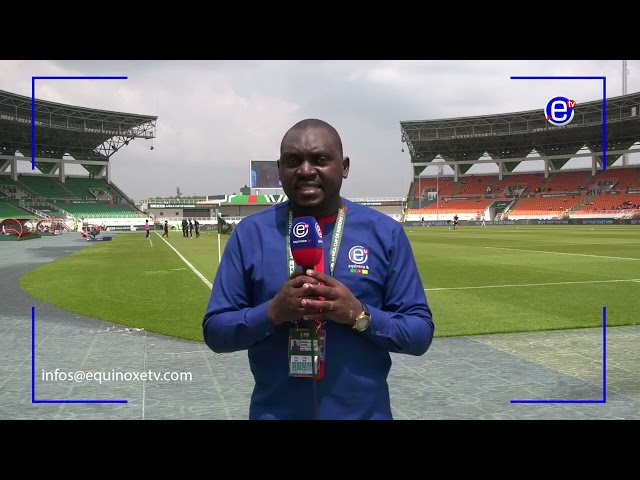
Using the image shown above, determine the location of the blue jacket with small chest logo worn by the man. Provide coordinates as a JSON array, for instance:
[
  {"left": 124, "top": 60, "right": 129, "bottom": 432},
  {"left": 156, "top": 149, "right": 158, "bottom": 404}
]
[{"left": 203, "top": 200, "right": 434, "bottom": 420}]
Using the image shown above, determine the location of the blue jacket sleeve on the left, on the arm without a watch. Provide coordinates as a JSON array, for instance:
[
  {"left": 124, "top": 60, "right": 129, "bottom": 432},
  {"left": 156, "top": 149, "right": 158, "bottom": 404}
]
[{"left": 202, "top": 228, "right": 276, "bottom": 353}]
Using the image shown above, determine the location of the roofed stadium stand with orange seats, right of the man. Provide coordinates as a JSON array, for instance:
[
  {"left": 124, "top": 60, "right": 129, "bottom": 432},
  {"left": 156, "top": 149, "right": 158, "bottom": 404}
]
[{"left": 400, "top": 93, "right": 640, "bottom": 222}]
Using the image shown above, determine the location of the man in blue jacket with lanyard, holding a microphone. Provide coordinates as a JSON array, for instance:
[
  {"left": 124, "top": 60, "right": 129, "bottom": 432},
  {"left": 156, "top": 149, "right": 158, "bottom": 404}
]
[{"left": 203, "top": 119, "right": 434, "bottom": 420}]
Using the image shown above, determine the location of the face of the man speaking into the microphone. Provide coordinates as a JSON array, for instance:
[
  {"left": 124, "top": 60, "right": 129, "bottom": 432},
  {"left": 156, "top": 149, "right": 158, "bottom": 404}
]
[{"left": 278, "top": 127, "right": 349, "bottom": 210}]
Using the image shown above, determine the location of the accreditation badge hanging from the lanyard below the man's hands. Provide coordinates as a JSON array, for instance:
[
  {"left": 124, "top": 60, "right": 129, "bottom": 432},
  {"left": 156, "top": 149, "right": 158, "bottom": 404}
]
[{"left": 288, "top": 328, "right": 326, "bottom": 378}]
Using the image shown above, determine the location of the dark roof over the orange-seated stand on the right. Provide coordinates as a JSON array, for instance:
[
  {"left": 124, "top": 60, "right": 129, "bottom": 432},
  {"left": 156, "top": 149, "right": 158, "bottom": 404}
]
[{"left": 400, "top": 93, "right": 640, "bottom": 175}]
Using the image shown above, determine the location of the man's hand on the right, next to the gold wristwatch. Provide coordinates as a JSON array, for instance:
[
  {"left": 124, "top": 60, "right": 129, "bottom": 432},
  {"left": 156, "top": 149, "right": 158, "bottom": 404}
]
[{"left": 301, "top": 270, "right": 362, "bottom": 325}]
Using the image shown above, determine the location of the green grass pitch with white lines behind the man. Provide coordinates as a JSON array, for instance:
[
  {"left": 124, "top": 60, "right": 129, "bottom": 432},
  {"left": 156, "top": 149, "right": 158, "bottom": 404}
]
[{"left": 20, "top": 225, "right": 640, "bottom": 341}]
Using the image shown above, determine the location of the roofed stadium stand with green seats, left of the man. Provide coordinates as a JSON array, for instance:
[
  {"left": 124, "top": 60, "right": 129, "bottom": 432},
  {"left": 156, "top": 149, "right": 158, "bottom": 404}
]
[{"left": 0, "top": 91, "right": 157, "bottom": 230}]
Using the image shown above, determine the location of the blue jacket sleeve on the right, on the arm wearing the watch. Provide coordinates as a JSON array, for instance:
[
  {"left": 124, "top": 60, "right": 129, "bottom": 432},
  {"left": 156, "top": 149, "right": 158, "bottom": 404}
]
[{"left": 364, "top": 226, "right": 435, "bottom": 356}]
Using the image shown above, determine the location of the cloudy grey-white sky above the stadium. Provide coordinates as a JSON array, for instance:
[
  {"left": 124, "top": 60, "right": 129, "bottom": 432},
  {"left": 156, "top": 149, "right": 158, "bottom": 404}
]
[{"left": 0, "top": 60, "right": 640, "bottom": 200}]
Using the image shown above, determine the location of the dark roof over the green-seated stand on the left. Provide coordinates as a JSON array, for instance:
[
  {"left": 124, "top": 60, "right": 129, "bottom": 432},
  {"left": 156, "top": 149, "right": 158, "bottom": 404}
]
[{"left": 0, "top": 90, "right": 158, "bottom": 170}]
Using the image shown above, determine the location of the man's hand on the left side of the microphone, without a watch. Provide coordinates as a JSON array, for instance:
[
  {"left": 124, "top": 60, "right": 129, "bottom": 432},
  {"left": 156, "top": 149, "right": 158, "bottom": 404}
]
[{"left": 267, "top": 271, "right": 318, "bottom": 325}]
